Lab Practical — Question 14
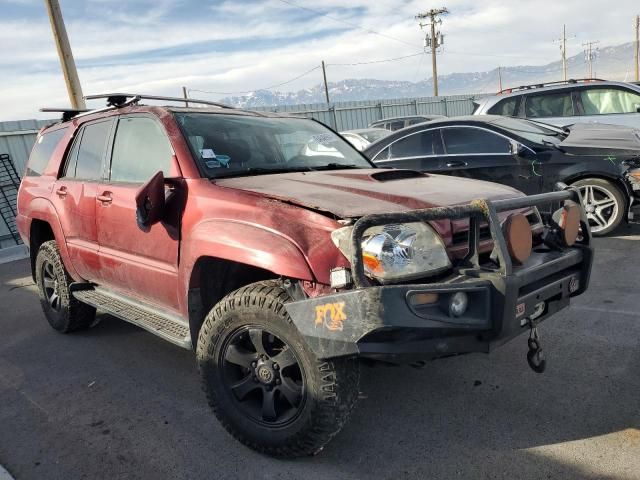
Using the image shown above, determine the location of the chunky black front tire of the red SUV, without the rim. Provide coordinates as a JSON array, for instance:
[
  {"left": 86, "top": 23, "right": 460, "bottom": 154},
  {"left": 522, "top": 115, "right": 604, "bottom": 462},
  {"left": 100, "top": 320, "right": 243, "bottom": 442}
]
[{"left": 197, "top": 280, "right": 360, "bottom": 458}]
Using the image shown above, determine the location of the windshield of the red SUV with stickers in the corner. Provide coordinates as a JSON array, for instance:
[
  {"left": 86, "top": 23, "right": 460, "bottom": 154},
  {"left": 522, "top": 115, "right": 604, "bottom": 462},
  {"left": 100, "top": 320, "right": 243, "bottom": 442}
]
[{"left": 175, "top": 112, "right": 373, "bottom": 178}]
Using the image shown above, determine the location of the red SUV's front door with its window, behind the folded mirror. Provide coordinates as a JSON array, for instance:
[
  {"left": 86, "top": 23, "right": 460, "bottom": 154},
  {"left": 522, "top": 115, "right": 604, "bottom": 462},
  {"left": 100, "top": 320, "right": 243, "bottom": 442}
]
[{"left": 96, "top": 114, "right": 181, "bottom": 311}]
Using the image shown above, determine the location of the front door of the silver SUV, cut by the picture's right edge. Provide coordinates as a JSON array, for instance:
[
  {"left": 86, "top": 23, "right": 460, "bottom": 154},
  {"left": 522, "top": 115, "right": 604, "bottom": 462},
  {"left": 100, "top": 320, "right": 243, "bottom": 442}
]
[{"left": 577, "top": 86, "right": 640, "bottom": 128}]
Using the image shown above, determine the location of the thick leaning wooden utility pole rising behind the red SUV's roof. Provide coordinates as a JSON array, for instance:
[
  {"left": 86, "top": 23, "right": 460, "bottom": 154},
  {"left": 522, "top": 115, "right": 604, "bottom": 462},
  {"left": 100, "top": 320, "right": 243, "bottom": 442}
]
[{"left": 44, "top": 0, "right": 86, "bottom": 110}]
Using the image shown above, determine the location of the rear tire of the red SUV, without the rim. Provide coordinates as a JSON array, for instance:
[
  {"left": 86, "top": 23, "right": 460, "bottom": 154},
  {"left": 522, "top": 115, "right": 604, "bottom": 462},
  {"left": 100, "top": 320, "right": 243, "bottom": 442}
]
[{"left": 36, "top": 240, "right": 96, "bottom": 333}]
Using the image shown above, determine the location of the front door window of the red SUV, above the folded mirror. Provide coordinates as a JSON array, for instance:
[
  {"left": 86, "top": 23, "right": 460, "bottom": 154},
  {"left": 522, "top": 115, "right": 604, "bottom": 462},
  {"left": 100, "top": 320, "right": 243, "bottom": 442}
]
[{"left": 110, "top": 117, "right": 173, "bottom": 183}]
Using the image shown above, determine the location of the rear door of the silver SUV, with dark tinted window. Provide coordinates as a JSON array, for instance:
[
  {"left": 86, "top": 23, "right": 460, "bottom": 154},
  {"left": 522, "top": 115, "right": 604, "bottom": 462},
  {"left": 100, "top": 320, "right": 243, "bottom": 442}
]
[{"left": 521, "top": 89, "right": 581, "bottom": 126}]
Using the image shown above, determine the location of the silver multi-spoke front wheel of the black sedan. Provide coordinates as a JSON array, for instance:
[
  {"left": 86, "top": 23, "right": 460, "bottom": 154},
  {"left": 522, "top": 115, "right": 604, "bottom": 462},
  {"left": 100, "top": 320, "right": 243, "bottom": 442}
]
[{"left": 573, "top": 178, "right": 626, "bottom": 237}]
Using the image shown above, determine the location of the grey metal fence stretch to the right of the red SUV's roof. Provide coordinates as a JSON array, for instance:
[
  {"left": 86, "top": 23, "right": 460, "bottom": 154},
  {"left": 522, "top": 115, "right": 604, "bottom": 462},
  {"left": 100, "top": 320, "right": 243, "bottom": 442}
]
[{"left": 253, "top": 95, "right": 483, "bottom": 131}]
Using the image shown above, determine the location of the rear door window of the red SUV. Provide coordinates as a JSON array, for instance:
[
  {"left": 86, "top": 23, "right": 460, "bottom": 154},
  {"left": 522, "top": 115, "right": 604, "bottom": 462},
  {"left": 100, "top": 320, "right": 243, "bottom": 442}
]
[{"left": 72, "top": 120, "right": 113, "bottom": 180}]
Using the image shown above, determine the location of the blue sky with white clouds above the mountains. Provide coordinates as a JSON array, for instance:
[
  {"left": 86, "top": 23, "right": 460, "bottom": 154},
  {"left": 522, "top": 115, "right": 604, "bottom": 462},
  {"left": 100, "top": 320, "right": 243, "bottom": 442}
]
[{"left": 0, "top": 0, "right": 640, "bottom": 120}]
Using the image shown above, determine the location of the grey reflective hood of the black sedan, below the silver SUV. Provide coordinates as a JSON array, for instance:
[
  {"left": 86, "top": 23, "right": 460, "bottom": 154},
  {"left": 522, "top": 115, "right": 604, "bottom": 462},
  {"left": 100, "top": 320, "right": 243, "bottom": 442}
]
[{"left": 558, "top": 123, "right": 640, "bottom": 156}]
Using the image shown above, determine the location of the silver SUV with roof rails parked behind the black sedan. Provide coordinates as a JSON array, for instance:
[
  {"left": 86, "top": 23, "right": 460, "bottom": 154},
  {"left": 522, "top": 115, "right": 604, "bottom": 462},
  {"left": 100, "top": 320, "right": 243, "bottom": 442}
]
[{"left": 473, "top": 79, "right": 640, "bottom": 128}]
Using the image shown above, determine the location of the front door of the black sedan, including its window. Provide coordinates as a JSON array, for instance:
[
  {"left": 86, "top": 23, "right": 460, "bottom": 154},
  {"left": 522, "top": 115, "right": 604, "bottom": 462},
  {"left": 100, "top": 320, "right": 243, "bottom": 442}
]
[{"left": 440, "top": 126, "right": 541, "bottom": 194}]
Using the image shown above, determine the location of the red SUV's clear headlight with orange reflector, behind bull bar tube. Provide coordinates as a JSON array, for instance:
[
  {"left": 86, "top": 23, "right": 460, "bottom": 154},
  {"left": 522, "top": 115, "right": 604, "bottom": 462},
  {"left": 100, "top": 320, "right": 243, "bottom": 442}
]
[{"left": 331, "top": 222, "right": 451, "bottom": 283}]
